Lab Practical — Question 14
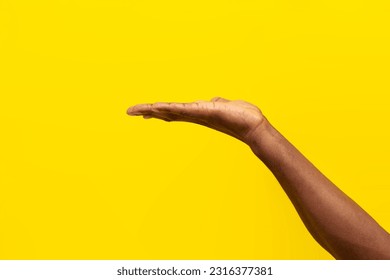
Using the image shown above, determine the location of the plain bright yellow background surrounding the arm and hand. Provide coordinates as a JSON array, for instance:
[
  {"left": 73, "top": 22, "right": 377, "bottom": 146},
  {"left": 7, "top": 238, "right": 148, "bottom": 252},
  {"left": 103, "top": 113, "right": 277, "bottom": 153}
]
[{"left": 0, "top": 0, "right": 390, "bottom": 259}]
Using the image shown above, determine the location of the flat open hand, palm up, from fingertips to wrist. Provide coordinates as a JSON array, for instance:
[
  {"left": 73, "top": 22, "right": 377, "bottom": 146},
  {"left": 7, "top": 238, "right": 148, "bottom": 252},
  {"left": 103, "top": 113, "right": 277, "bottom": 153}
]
[{"left": 127, "top": 97, "right": 265, "bottom": 145}]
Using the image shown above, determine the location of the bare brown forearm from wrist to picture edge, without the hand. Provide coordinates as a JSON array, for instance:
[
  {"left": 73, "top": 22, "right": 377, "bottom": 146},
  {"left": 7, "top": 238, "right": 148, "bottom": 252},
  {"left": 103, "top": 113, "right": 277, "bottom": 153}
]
[{"left": 248, "top": 119, "right": 390, "bottom": 259}]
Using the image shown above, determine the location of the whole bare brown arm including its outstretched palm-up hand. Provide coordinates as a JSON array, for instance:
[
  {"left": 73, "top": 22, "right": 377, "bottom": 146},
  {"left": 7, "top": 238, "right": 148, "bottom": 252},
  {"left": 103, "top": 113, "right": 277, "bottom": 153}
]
[{"left": 127, "top": 97, "right": 390, "bottom": 259}]
